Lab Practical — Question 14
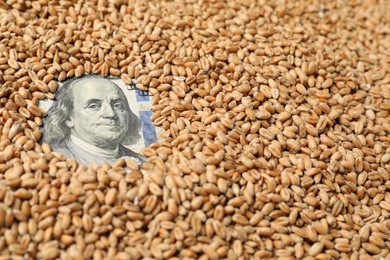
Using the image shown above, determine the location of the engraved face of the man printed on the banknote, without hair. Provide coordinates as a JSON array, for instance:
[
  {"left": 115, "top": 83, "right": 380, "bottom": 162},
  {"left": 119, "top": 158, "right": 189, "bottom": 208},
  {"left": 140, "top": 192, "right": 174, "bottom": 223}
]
[{"left": 66, "top": 79, "right": 129, "bottom": 149}]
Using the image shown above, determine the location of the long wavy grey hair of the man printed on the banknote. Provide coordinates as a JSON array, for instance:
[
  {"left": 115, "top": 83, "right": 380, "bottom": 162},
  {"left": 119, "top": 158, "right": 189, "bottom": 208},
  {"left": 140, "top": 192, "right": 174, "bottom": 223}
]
[{"left": 42, "top": 75, "right": 141, "bottom": 147}]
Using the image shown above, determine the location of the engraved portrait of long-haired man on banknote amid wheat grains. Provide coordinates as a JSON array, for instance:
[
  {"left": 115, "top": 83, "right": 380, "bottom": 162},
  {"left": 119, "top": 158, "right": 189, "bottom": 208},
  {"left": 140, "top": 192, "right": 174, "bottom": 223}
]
[{"left": 43, "top": 75, "right": 146, "bottom": 164}]
